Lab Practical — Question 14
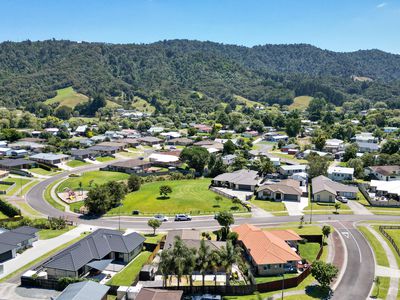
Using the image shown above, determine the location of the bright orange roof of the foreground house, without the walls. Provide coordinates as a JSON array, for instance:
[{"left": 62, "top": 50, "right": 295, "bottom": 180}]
[{"left": 233, "top": 224, "right": 301, "bottom": 265}]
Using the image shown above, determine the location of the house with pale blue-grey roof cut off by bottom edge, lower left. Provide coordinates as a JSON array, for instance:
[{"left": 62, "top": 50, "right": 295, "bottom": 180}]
[{"left": 54, "top": 280, "right": 110, "bottom": 300}]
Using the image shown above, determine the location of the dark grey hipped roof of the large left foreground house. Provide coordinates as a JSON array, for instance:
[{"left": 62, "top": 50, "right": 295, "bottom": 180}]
[{"left": 43, "top": 229, "right": 145, "bottom": 271}]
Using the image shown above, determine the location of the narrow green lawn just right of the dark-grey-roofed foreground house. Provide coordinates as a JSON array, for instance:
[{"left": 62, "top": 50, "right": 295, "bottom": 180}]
[{"left": 107, "top": 251, "right": 151, "bottom": 286}]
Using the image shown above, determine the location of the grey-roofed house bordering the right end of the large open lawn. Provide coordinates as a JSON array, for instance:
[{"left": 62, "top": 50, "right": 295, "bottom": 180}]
[{"left": 212, "top": 170, "right": 261, "bottom": 191}]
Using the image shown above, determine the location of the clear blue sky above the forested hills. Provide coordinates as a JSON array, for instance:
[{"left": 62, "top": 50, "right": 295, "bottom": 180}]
[{"left": 0, "top": 0, "right": 400, "bottom": 54}]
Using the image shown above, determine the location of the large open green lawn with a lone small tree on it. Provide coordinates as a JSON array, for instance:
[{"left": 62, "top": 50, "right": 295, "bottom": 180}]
[{"left": 110, "top": 179, "right": 244, "bottom": 215}]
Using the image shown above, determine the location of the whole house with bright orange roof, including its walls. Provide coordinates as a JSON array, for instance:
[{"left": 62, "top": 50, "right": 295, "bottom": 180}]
[{"left": 233, "top": 224, "right": 302, "bottom": 276}]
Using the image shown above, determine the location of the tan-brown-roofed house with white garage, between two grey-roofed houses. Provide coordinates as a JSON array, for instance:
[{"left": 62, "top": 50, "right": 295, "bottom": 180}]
[{"left": 257, "top": 179, "right": 303, "bottom": 202}]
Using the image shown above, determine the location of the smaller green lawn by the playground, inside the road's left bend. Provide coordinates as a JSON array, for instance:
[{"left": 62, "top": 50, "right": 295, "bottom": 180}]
[{"left": 57, "top": 171, "right": 129, "bottom": 192}]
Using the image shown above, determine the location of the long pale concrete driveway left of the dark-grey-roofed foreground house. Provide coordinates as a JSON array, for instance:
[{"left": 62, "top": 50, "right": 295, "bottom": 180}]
[{"left": 0, "top": 225, "right": 94, "bottom": 282}]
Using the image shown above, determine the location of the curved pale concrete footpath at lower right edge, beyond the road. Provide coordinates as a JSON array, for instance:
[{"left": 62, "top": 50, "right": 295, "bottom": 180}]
[{"left": 367, "top": 226, "right": 400, "bottom": 300}]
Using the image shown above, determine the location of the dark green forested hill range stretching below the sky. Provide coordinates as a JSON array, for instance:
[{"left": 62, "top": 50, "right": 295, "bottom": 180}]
[{"left": 0, "top": 40, "right": 400, "bottom": 109}]
